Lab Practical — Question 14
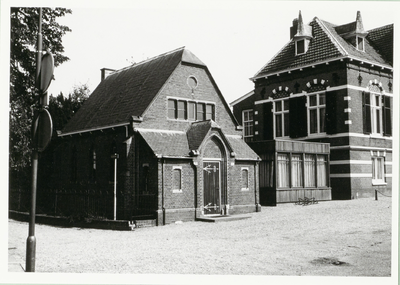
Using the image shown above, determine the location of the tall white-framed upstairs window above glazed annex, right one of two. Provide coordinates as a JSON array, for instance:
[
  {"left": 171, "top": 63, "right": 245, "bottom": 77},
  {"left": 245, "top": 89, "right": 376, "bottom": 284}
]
[{"left": 308, "top": 94, "right": 326, "bottom": 134}]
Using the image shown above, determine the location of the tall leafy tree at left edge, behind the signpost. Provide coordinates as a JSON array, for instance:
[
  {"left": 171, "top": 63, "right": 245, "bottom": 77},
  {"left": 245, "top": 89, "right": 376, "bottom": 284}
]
[{"left": 9, "top": 7, "right": 72, "bottom": 172}]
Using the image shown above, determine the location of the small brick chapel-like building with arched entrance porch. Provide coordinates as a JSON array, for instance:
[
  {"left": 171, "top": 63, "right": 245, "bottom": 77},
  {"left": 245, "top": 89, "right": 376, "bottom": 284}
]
[{"left": 46, "top": 48, "right": 260, "bottom": 225}]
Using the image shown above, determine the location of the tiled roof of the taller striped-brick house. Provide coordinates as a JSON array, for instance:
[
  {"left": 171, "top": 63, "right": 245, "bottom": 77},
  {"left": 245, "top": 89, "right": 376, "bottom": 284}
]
[{"left": 253, "top": 17, "right": 393, "bottom": 79}]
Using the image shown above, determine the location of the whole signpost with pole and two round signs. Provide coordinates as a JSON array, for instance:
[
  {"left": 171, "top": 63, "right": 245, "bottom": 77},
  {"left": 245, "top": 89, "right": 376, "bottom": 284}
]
[{"left": 25, "top": 8, "right": 54, "bottom": 272}]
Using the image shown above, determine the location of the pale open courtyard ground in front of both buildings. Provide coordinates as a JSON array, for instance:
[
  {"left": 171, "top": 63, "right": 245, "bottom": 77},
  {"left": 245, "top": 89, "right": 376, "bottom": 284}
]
[{"left": 8, "top": 197, "right": 393, "bottom": 282}]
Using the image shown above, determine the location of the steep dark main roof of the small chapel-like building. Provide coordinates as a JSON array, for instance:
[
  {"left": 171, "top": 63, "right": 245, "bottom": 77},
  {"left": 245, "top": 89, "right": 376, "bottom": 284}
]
[{"left": 63, "top": 48, "right": 205, "bottom": 133}]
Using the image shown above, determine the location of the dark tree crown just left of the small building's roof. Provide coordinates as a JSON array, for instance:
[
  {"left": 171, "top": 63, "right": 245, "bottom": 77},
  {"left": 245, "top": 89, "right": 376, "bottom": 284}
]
[{"left": 49, "top": 84, "right": 90, "bottom": 132}]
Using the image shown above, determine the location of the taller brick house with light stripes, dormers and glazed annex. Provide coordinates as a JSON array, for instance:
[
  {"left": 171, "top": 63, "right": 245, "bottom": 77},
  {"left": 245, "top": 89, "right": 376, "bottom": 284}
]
[{"left": 231, "top": 12, "right": 393, "bottom": 202}]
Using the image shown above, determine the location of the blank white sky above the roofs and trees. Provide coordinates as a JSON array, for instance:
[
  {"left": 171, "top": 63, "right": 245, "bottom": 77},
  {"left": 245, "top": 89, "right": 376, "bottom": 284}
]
[{"left": 3, "top": 0, "right": 398, "bottom": 103}]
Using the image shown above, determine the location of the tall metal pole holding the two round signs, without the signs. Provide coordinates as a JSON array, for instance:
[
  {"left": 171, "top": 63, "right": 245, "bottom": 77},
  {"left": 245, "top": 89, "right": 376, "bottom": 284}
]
[{"left": 25, "top": 8, "right": 42, "bottom": 272}]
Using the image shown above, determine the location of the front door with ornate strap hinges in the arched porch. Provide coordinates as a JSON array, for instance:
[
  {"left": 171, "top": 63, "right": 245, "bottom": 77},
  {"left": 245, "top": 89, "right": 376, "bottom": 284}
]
[{"left": 203, "top": 161, "right": 221, "bottom": 215}]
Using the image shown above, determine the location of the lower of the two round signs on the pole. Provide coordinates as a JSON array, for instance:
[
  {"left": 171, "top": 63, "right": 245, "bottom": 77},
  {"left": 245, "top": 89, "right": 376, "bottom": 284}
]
[{"left": 32, "top": 109, "right": 53, "bottom": 152}]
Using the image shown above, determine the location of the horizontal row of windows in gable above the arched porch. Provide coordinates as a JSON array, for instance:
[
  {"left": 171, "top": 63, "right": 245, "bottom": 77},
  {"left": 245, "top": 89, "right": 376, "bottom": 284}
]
[{"left": 168, "top": 99, "right": 215, "bottom": 121}]
